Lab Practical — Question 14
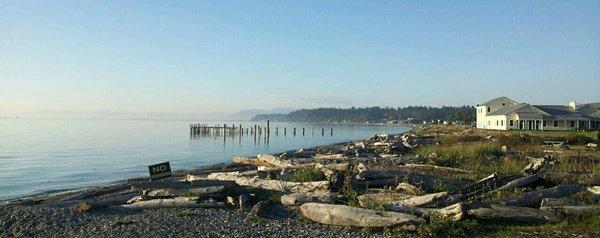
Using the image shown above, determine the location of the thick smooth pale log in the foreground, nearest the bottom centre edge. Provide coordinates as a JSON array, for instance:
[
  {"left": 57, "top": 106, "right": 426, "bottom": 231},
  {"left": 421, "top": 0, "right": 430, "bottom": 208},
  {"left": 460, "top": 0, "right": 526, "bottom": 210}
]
[{"left": 300, "top": 203, "right": 425, "bottom": 229}]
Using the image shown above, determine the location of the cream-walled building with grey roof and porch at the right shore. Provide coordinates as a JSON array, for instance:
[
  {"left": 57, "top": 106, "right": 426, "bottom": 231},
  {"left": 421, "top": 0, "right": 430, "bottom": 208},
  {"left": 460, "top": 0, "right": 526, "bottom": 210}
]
[{"left": 476, "top": 97, "right": 600, "bottom": 131}]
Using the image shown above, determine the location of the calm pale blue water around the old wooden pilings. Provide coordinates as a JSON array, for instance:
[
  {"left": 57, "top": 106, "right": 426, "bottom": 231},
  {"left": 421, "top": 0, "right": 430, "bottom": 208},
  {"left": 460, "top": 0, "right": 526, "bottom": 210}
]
[{"left": 0, "top": 119, "right": 408, "bottom": 199}]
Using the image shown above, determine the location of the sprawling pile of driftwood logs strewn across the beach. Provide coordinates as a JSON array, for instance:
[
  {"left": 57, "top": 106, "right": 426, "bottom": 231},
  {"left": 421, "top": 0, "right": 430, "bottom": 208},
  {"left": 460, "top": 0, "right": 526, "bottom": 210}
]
[{"left": 57, "top": 131, "right": 600, "bottom": 229}]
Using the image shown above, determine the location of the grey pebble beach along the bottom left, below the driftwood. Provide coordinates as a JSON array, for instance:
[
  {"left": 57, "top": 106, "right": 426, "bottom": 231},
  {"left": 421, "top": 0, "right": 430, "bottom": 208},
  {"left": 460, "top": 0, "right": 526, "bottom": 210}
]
[{"left": 0, "top": 205, "right": 381, "bottom": 237}]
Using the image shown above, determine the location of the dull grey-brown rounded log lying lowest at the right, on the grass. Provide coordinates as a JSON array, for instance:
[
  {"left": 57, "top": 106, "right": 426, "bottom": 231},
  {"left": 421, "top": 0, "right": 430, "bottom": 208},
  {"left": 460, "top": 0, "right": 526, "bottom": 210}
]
[{"left": 467, "top": 205, "right": 558, "bottom": 222}]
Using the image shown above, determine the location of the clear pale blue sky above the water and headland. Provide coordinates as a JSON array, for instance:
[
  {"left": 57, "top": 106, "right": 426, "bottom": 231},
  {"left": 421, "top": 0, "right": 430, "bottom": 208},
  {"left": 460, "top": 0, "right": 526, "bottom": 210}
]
[{"left": 0, "top": 0, "right": 600, "bottom": 118}]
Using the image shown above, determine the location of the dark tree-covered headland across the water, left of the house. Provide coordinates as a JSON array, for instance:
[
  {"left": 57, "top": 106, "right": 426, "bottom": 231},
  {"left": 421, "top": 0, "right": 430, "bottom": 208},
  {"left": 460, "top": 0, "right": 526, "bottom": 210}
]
[{"left": 252, "top": 106, "right": 475, "bottom": 122}]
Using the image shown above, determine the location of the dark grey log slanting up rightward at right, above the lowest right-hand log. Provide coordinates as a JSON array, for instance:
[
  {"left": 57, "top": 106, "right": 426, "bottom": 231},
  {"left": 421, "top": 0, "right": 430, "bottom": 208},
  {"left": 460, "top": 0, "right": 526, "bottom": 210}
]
[{"left": 499, "top": 184, "right": 583, "bottom": 207}]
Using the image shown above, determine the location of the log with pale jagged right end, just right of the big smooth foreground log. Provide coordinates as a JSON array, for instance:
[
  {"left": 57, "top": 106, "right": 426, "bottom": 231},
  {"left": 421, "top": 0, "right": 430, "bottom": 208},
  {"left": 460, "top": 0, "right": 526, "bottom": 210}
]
[{"left": 383, "top": 203, "right": 466, "bottom": 221}]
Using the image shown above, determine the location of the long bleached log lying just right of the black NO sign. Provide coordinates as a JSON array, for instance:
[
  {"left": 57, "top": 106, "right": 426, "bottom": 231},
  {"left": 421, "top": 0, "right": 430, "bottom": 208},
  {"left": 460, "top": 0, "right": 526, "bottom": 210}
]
[{"left": 208, "top": 173, "right": 329, "bottom": 193}]
